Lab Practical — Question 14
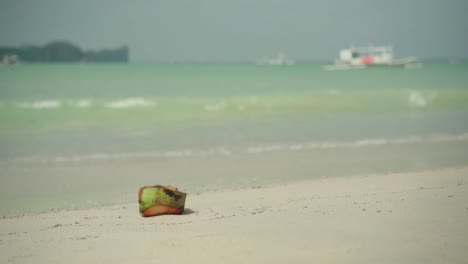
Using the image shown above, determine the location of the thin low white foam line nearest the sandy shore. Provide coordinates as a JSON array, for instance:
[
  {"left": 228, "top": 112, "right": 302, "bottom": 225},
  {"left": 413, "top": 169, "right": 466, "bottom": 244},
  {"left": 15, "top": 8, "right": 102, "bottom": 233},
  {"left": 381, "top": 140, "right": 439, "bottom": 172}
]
[{"left": 7, "top": 132, "right": 468, "bottom": 164}]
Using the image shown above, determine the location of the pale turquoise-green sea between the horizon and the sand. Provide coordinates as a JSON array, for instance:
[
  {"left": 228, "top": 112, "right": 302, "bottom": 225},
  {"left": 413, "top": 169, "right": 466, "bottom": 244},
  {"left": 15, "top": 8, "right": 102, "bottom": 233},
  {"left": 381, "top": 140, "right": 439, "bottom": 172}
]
[{"left": 0, "top": 63, "right": 468, "bottom": 216}]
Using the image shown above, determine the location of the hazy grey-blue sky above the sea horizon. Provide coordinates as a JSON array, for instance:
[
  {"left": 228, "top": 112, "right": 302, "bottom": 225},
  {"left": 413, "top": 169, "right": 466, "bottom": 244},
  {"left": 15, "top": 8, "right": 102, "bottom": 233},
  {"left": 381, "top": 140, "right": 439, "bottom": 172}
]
[{"left": 0, "top": 0, "right": 468, "bottom": 61}]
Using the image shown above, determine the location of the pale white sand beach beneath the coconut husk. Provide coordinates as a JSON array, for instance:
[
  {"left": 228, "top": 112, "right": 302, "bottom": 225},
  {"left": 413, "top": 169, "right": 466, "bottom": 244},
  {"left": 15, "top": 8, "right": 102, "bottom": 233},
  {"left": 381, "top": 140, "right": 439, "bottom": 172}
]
[{"left": 0, "top": 167, "right": 468, "bottom": 264}]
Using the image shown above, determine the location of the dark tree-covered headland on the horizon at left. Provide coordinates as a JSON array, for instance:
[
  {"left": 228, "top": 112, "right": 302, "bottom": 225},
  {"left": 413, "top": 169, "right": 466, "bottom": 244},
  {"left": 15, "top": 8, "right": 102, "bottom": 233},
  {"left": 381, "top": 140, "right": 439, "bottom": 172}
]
[{"left": 0, "top": 41, "right": 129, "bottom": 63}]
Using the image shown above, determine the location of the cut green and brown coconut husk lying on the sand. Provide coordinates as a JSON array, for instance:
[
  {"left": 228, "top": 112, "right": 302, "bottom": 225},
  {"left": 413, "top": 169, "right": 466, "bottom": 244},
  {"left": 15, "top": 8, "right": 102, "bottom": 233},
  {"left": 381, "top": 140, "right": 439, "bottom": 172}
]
[{"left": 138, "top": 185, "right": 187, "bottom": 217}]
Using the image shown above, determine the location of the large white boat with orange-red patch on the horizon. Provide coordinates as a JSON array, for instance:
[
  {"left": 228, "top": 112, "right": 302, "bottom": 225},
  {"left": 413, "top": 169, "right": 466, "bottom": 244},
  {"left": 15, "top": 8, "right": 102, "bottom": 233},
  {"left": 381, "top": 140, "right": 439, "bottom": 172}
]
[{"left": 325, "top": 44, "right": 421, "bottom": 70}]
